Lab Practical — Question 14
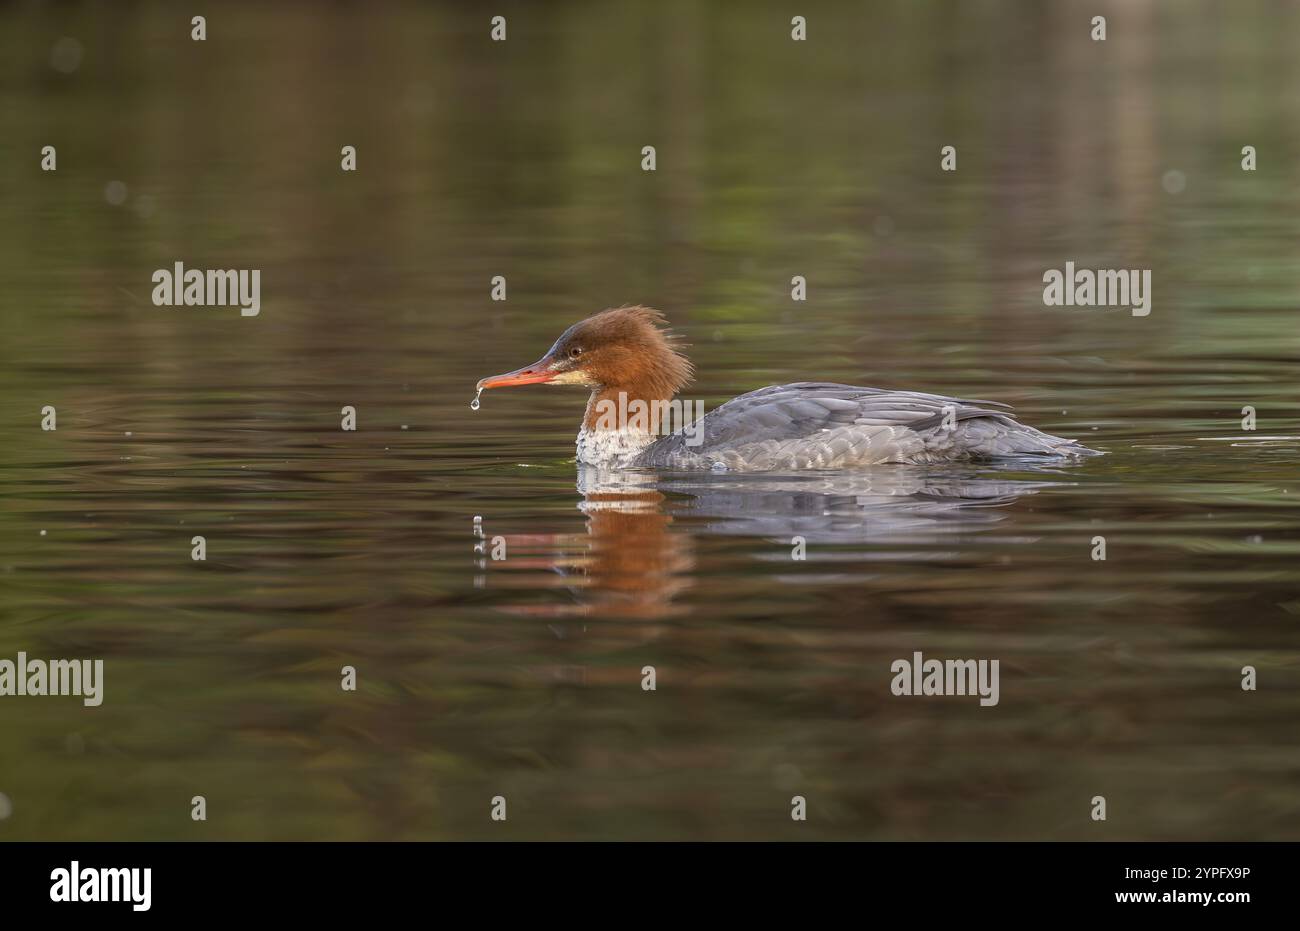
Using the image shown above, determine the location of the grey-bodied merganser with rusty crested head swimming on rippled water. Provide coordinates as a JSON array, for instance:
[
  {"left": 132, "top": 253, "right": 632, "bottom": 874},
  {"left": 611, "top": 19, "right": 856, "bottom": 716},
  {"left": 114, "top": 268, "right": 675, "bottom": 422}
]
[{"left": 475, "top": 307, "right": 1099, "bottom": 472}]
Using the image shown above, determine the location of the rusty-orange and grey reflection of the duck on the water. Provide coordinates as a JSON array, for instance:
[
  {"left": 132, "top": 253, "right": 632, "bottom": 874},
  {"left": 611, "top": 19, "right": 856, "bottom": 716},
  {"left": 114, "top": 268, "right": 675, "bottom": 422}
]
[{"left": 488, "top": 466, "right": 1067, "bottom": 626}]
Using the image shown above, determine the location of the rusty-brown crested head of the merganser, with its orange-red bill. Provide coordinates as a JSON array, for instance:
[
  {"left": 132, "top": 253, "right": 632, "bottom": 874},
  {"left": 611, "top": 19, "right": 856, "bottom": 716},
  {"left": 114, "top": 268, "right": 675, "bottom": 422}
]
[{"left": 478, "top": 307, "right": 693, "bottom": 399}]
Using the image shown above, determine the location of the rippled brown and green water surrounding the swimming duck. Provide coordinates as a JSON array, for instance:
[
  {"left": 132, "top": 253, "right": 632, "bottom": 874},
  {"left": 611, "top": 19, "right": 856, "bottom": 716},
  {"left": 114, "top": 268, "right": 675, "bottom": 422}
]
[{"left": 0, "top": 0, "right": 1300, "bottom": 840}]
